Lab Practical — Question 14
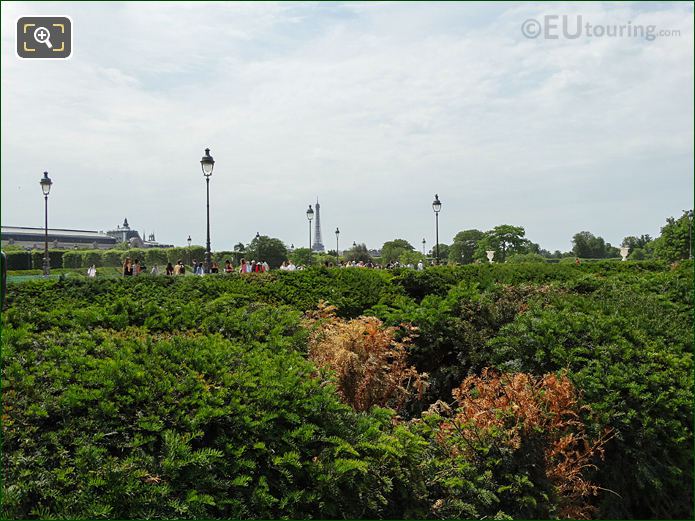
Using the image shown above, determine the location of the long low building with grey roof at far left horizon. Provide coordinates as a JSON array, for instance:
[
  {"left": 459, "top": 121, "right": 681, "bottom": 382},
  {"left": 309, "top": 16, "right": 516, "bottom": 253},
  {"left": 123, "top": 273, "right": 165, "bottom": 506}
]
[{"left": 0, "top": 226, "right": 117, "bottom": 250}]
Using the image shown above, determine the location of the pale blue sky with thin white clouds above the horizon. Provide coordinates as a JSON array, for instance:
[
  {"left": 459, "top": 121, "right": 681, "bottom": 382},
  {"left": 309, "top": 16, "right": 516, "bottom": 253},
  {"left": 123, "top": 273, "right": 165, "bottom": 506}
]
[{"left": 0, "top": 2, "right": 694, "bottom": 251}]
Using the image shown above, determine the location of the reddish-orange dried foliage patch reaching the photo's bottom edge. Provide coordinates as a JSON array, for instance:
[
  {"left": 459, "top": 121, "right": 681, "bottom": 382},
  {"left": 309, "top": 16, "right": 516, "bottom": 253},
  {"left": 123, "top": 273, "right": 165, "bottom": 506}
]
[{"left": 440, "top": 369, "right": 610, "bottom": 519}]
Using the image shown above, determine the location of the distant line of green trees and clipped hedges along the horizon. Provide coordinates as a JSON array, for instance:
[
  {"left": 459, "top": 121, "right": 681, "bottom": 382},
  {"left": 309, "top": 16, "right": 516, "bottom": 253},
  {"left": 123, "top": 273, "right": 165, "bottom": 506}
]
[{"left": 5, "top": 210, "right": 693, "bottom": 270}]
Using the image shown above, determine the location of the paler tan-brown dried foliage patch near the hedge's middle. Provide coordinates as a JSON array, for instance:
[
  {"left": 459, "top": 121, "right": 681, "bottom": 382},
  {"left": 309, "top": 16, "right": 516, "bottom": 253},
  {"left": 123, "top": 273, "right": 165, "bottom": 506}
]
[{"left": 307, "top": 302, "right": 427, "bottom": 411}]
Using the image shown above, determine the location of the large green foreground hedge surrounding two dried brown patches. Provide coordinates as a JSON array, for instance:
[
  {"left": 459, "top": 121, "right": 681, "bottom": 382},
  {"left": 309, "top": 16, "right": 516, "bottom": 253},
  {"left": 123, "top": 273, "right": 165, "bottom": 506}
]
[{"left": 2, "top": 262, "right": 693, "bottom": 519}]
